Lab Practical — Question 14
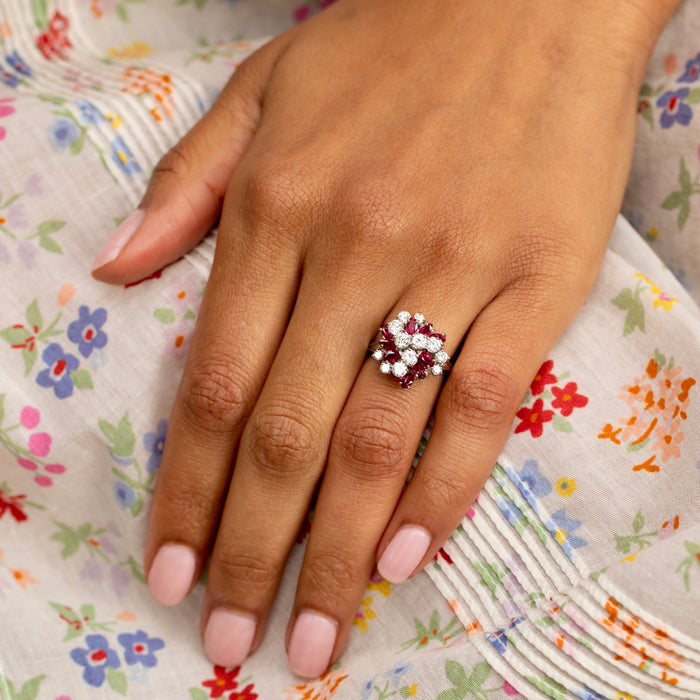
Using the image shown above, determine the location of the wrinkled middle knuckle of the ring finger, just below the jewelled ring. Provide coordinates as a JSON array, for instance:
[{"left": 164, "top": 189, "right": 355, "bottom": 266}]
[{"left": 331, "top": 406, "right": 413, "bottom": 480}]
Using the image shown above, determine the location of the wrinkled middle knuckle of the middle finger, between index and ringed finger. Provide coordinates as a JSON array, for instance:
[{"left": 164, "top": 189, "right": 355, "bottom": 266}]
[{"left": 244, "top": 408, "right": 320, "bottom": 480}]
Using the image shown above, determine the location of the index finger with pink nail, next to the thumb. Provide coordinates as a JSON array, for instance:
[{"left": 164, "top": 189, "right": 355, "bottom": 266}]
[{"left": 144, "top": 189, "right": 300, "bottom": 605}]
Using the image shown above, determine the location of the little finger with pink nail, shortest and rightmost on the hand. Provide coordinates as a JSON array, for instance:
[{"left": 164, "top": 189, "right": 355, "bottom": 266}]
[{"left": 377, "top": 278, "right": 583, "bottom": 583}]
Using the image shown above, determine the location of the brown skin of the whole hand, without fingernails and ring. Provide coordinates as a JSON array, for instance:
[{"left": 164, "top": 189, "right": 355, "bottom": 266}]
[{"left": 94, "top": 0, "right": 677, "bottom": 680}]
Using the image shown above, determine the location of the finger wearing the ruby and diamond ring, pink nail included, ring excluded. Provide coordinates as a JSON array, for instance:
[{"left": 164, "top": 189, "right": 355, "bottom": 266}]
[{"left": 288, "top": 304, "right": 484, "bottom": 677}]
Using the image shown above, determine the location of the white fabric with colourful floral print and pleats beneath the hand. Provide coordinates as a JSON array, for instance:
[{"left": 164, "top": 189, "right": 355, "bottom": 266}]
[{"left": 0, "top": 0, "right": 700, "bottom": 700}]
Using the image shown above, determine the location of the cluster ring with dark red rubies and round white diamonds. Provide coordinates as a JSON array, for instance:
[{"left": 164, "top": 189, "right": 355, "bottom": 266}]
[{"left": 370, "top": 311, "right": 450, "bottom": 389}]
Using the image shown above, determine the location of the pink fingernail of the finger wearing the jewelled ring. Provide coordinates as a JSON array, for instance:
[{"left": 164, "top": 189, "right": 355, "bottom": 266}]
[{"left": 288, "top": 610, "right": 338, "bottom": 678}]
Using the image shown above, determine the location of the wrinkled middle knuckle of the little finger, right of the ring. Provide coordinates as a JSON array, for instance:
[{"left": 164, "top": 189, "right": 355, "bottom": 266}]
[{"left": 442, "top": 364, "right": 519, "bottom": 430}]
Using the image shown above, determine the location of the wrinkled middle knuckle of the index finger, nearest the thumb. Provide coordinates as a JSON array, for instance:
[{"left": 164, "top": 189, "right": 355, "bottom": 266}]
[{"left": 182, "top": 355, "right": 251, "bottom": 433}]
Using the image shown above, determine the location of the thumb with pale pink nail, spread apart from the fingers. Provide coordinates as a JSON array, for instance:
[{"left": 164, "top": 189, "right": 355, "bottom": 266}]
[{"left": 92, "top": 35, "right": 288, "bottom": 284}]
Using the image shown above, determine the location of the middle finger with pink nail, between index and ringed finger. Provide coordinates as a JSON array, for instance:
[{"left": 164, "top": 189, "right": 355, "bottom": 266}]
[{"left": 197, "top": 278, "right": 400, "bottom": 667}]
